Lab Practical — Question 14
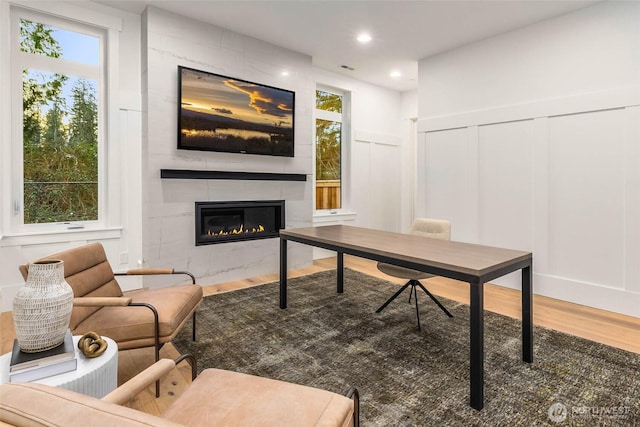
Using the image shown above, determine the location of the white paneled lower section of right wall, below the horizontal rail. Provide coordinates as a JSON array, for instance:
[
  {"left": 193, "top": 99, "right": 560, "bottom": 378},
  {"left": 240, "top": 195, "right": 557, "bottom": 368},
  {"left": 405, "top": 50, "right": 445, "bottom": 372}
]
[{"left": 419, "top": 102, "right": 640, "bottom": 316}]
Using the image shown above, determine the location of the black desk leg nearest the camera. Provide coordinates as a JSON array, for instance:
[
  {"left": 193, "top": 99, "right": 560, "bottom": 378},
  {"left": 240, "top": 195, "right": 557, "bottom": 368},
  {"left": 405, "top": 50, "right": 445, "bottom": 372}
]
[{"left": 469, "top": 283, "right": 484, "bottom": 410}]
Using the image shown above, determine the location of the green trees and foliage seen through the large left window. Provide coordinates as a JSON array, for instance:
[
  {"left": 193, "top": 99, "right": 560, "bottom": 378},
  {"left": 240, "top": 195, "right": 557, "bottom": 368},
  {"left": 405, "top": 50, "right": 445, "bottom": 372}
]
[{"left": 20, "top": 20, "right": 98, "bottom": 224}]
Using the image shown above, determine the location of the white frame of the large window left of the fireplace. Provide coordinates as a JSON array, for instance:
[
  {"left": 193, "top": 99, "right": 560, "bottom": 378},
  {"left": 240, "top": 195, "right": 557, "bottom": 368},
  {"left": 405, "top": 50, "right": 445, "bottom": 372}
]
[{"left": 0, "top": 2, "right": 123, "bottom": 246}]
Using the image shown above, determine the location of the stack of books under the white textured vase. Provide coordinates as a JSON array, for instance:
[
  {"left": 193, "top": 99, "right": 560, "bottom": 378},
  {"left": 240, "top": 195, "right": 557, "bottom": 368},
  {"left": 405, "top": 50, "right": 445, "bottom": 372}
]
[{"left": 9, "top": 330, "right": 78, "bottom": 382}]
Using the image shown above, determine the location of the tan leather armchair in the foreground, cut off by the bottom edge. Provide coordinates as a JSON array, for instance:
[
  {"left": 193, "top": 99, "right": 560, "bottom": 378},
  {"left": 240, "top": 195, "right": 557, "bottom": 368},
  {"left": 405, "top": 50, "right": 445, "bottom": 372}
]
[{"left": 0, "top": 359, "right": 359, "bottom": 427}]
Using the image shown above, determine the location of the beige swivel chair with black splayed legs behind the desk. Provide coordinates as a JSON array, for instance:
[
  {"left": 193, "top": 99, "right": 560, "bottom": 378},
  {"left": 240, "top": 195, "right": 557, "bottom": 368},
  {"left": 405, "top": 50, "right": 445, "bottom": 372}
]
[{"left": 376, "top": 218, "right": 453, "bottom": 330}]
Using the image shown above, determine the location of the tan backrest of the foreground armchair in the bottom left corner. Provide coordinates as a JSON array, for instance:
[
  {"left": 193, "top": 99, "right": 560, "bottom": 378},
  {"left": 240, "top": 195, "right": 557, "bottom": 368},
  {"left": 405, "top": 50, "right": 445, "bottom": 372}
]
[{"left": 0, "top": 383, "right": 177, "bottom": 427}]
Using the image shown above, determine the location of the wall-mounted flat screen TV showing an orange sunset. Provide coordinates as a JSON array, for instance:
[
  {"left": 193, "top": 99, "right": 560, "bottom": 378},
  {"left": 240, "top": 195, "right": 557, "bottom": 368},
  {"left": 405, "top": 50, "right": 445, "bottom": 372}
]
[{"left": 178, "top": 66, "right": 295, "bottom": 157}]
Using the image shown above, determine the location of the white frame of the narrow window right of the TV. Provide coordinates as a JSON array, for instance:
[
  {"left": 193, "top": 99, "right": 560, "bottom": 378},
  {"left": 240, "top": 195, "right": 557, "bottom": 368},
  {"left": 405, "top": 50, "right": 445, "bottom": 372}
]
[{"left": 312, "top": 84, "right": 351, "bottom": 217}]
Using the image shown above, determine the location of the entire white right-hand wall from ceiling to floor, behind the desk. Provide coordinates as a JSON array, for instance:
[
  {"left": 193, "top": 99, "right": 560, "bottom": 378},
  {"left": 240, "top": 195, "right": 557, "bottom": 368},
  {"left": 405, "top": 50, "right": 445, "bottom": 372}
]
[{"left": 417, "top": 2, "right": 640, "bottom": 317}]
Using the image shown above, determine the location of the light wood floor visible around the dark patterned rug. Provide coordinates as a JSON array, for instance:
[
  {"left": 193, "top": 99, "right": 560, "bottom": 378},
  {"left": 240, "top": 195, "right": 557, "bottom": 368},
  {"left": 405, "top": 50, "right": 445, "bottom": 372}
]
[{"left": 0, "top": 256, "right": 640, "bottom": 414}]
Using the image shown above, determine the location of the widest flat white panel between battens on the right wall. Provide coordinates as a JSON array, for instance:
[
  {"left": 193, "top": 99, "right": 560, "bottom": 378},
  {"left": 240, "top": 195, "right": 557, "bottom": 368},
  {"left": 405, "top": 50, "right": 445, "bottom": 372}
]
[{"left": 548, "top": 109, "right": 631, "bottom": 288}]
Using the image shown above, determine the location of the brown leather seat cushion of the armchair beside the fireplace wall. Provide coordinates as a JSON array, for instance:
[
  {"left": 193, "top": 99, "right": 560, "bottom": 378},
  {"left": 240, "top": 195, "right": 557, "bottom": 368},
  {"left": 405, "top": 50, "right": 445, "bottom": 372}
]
[{"left": 73, "top": 285, "right": 202, "bottom": 350}]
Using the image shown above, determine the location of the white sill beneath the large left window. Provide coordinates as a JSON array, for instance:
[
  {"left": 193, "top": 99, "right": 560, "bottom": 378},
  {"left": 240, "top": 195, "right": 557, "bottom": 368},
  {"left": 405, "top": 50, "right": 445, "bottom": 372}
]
[{"left": 0, "top": 227, "right": 122, "bottom": 247}]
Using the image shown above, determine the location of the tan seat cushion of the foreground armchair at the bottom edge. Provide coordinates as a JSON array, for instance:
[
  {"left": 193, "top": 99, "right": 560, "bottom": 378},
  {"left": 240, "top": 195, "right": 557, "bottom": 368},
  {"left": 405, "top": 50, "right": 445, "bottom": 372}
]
[{"left": 162, "top": 369, "right": 353, "bottom": 427}]
